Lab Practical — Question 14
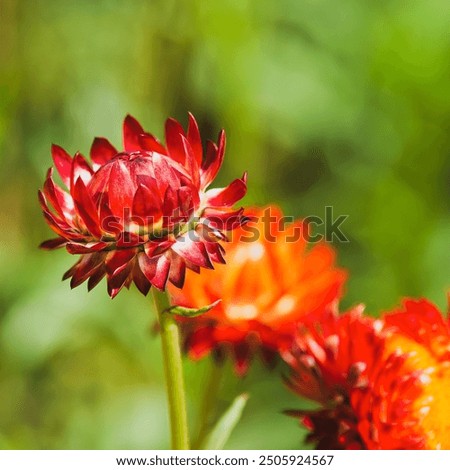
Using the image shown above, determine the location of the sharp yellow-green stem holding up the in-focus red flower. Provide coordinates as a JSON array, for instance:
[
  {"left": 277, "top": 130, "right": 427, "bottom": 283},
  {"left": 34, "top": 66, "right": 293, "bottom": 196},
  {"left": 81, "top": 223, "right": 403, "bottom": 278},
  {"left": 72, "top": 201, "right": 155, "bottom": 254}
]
[{"left": 152, "top": 288, "right": 189, "bottom": 450}]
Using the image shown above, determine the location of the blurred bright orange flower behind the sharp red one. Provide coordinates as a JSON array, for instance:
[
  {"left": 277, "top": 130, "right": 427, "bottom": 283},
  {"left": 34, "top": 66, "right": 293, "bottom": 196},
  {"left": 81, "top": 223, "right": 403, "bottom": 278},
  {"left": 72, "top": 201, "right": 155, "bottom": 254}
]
[{"left": 170, "top": 206, "right": 346, "bottom": 373}]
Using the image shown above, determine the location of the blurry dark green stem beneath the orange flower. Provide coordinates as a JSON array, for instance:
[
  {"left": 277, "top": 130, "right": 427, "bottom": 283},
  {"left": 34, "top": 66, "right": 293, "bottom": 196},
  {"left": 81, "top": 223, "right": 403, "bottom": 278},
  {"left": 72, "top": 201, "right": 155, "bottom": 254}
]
[{"left": 194, "top": 359, "right": 223, "bottom": 449}]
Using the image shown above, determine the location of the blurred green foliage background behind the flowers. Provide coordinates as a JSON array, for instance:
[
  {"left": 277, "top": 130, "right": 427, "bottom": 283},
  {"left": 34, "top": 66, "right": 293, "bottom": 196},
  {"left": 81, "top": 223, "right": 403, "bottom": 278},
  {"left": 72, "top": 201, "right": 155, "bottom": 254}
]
[{"left": 0, "top": 0, "right": 450, "bottom": 449}]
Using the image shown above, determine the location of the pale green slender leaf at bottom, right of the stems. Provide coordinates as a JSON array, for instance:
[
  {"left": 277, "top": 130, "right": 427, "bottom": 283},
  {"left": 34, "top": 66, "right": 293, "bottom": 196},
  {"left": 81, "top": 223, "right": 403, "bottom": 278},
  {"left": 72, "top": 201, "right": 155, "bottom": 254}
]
[{"left": 202, "top": 393, "right": 248, "bottom": 450}]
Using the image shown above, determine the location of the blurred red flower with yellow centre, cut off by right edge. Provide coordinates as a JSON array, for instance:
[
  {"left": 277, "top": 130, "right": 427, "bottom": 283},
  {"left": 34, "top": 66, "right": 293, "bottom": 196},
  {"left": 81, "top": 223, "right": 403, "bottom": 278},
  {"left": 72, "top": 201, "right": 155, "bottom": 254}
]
[{"left": 284, "top": 300, "right": 450, "bottom": 449}]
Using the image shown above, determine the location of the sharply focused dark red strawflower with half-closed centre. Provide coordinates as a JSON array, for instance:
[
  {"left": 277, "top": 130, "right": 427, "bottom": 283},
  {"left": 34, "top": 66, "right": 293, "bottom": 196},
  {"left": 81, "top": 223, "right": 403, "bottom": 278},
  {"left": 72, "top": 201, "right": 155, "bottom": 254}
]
[{"left": 39, "top": 115, "right": 246, "bottom": 297}]
